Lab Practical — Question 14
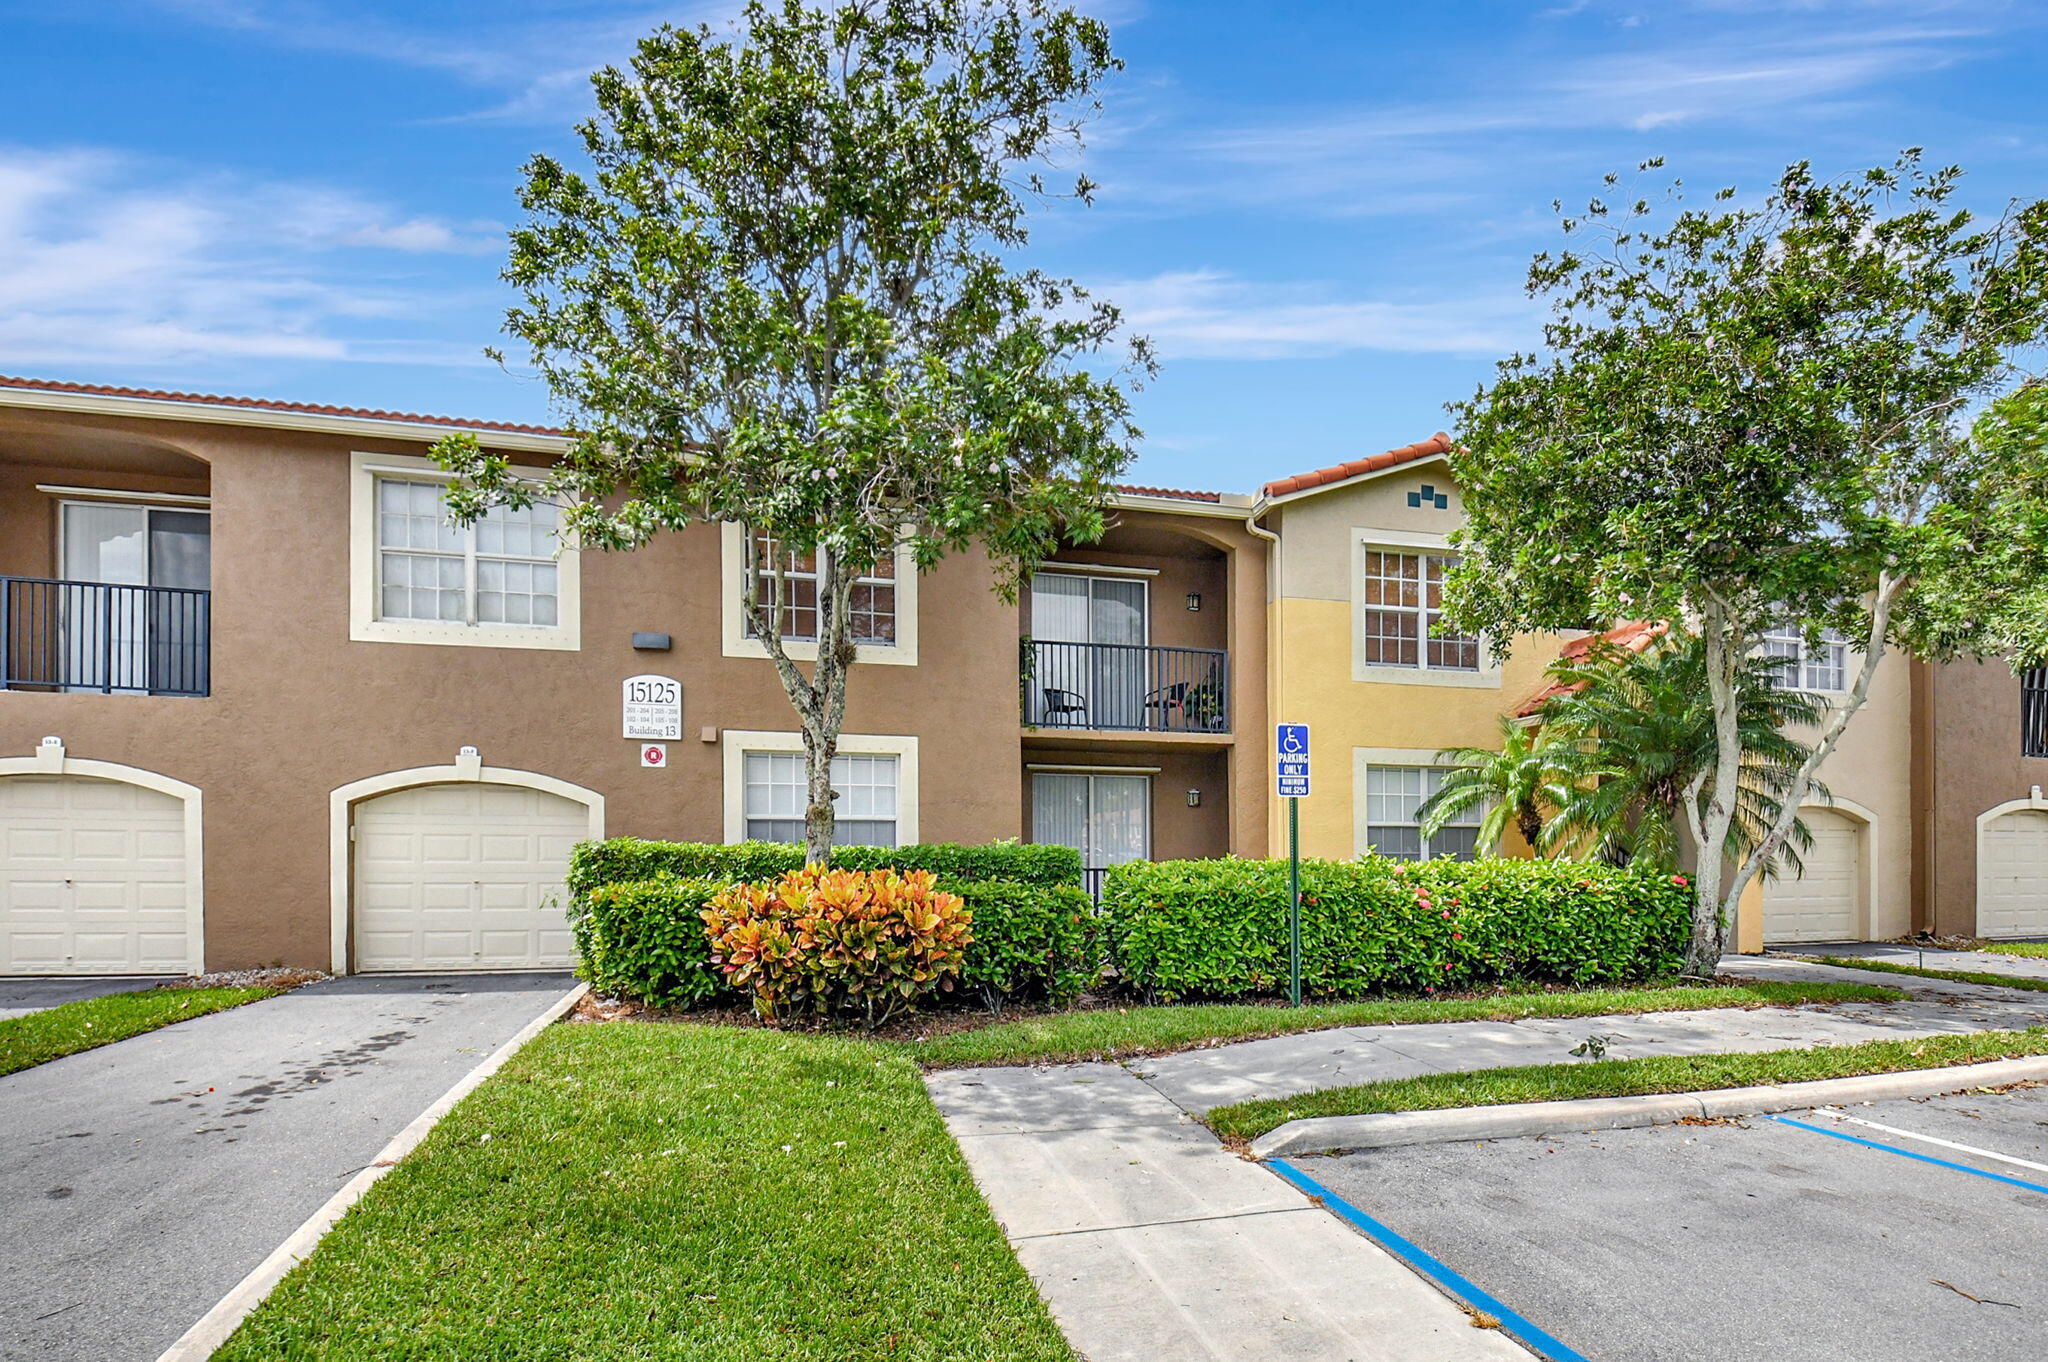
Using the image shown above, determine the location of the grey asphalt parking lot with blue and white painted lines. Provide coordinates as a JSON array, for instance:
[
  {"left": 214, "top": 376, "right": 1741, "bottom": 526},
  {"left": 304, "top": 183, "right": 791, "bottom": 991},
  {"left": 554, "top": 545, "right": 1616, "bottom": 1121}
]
[{"left": 1288, "top": 1088, "right": 2048, "bottom": 1362}]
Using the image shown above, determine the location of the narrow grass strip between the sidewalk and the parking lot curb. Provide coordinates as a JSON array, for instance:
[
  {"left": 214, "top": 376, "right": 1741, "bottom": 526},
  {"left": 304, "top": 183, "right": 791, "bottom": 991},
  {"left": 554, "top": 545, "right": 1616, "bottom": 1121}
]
[{"left": 1208, "top": 1026, "right": 2048, "bottom": 1139}]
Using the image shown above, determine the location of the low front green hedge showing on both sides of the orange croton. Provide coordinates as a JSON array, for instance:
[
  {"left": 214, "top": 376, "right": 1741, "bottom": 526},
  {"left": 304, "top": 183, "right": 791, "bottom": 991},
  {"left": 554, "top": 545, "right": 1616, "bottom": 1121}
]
[{"left": 569, "top": 860, "right": 1100, "bottom": 1010}]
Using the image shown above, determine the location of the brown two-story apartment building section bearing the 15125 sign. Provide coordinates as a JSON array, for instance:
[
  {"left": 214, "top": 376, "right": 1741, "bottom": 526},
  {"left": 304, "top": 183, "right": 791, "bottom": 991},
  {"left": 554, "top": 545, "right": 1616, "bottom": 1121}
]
[{"left": 0, "top": 381, "right": 1268, "bottom": 975}]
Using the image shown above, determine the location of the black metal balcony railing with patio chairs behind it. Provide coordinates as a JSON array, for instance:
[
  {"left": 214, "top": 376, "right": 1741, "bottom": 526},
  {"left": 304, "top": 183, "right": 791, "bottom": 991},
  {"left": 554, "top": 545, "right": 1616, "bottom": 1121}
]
[{"left": 1024, "top": 639, "right": 1231, "bottom": 733}]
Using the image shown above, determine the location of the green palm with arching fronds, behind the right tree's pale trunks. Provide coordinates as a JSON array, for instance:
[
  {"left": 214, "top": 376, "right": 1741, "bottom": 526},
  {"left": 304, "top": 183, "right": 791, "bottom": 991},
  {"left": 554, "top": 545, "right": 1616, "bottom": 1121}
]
[{"left": 1540, "top": 631, "right": 1827, "bottom": 870}]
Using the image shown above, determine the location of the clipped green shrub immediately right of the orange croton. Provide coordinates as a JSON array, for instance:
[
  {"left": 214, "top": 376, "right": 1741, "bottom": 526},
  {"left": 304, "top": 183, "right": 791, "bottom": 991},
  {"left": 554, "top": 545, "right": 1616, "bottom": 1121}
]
[{"left": 940, "top": 881, "right": 1102, "bottom": 1012}]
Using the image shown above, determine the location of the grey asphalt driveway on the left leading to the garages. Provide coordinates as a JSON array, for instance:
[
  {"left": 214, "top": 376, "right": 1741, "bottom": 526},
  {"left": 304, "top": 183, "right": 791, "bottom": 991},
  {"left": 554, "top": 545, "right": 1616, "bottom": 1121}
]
[{"left": 0, "top": 973, "right": 573, "bottom": 1362}]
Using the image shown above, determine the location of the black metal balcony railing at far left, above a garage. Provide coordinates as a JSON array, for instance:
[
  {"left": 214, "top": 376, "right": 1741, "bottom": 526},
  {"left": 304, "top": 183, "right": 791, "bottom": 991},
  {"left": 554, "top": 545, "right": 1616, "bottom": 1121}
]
[{"left": 0, "top": 578, "right": 213, "bottom": 694}]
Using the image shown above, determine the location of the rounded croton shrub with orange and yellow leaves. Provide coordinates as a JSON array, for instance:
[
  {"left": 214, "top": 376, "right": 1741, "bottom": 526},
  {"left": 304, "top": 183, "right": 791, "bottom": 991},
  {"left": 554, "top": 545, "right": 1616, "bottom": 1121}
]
[{"left": 702, "top": 868, "right": 975, "bottom": 1030}]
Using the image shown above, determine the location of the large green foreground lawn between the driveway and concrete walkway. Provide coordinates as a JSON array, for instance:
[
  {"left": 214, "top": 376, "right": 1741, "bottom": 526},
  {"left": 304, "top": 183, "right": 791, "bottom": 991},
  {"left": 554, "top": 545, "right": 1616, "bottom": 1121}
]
[{"left": 215, "top": 1024, "right": 1071, "bottom": 1362}]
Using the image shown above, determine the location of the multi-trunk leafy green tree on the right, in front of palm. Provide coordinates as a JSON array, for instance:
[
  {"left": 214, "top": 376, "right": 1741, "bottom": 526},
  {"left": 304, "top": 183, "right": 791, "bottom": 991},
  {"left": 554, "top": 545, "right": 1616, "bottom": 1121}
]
[{"left": 1452, "top": 152, "right": 2048, "bottom": 973}]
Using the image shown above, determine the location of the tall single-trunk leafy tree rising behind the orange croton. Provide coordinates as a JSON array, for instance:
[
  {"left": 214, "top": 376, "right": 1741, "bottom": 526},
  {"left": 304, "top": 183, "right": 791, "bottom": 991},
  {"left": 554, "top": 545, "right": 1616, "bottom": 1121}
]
[{"left": 440, "top": 0, "right": 1151, "bottom": 862}]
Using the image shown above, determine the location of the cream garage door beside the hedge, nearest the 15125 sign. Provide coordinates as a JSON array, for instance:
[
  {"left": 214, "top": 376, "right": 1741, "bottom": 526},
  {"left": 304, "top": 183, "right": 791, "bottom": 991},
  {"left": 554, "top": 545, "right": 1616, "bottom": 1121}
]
[{"left": 354, "top": 780, "right": 590, "bottom": 969}]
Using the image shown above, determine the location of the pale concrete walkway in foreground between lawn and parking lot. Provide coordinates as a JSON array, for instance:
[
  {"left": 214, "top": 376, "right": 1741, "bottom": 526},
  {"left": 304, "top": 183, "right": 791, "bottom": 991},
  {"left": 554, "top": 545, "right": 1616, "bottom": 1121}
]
[{"left": 926, "top": 1065, "right": 1530, "bottom": 1362}]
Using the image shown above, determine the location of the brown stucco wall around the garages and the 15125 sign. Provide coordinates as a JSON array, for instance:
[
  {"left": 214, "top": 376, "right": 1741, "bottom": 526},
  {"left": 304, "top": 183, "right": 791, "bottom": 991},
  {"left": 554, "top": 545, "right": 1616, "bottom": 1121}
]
[{"left": 0, "top": 412, "right": 1040, "bottom": 967}]
